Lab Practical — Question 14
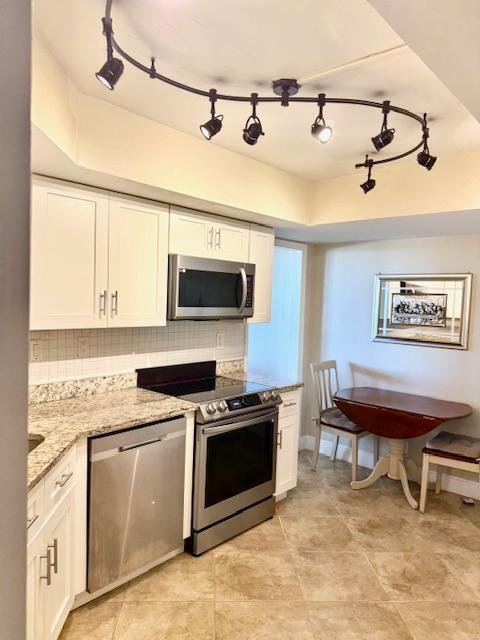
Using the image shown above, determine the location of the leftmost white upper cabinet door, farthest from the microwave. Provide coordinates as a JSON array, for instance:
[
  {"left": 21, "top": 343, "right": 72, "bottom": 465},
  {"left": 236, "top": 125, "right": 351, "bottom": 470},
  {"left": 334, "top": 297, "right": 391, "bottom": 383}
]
[{"left": 30, "top": 181, "right": 108, "bottom": 329}]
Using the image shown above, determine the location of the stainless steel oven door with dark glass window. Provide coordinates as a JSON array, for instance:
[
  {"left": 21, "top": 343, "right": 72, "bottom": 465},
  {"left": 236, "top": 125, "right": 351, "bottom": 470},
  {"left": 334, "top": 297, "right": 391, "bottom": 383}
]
[{"left": 193, "top": 409, "right": 278, "bottom": 531}]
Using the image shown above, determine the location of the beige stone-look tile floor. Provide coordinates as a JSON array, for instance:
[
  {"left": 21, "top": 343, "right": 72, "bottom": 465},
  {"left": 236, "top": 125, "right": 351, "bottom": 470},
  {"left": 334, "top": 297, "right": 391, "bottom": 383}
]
[{"left": 62, "top": 452, "right": 480, "bottom": 640}]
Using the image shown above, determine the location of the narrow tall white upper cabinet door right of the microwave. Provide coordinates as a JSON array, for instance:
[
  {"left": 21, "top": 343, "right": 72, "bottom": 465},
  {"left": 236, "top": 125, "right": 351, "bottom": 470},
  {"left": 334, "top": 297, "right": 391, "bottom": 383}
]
[{"left": 248, "top": 225, "right": 275, "bottom": 322}]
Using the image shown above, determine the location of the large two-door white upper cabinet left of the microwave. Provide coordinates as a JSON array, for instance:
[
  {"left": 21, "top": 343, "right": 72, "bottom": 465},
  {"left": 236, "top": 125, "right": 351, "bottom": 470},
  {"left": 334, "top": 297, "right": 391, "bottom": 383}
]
[{"left": 30, "top": 180, "right": 169, "bottom": 330}]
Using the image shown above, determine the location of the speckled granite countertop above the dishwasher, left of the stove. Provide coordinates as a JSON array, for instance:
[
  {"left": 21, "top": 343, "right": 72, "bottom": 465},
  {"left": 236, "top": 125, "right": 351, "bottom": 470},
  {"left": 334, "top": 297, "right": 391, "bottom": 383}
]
[{"left": 27, "top": 387, "right": 197, "bottom": 489}]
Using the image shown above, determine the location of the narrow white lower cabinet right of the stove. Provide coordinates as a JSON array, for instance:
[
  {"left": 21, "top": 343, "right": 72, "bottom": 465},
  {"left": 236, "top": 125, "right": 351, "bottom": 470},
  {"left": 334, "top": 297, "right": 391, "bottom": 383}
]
[{"left": 275, "top": 389, "right": 301, "bottom": 497}]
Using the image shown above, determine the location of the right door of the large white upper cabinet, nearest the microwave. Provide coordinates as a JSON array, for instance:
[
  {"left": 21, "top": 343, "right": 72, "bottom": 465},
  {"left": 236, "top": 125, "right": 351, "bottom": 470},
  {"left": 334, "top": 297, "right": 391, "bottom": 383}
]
[{"left": 108, "top": 196, "right": 168, "bottom": 327}]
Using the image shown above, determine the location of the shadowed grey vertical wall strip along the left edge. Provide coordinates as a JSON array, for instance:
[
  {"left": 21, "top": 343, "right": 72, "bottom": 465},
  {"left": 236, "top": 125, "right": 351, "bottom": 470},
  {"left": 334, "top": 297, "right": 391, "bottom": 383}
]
[{"left": 0, "top": 0, "right": 30, "bottom": 640}]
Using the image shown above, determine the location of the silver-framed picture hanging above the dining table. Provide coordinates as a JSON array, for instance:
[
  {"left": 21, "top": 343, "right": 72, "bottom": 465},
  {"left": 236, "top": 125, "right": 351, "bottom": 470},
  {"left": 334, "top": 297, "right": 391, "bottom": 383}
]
[{"left": 372, "top": 273, "right": 472, "bottom": 349}]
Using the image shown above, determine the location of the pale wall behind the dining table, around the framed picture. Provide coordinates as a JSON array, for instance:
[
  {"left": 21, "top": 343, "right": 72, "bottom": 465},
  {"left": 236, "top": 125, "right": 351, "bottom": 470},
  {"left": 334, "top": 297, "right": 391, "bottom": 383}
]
[{"left": 303, "top": 235, "right": 480, "bottom": 468}]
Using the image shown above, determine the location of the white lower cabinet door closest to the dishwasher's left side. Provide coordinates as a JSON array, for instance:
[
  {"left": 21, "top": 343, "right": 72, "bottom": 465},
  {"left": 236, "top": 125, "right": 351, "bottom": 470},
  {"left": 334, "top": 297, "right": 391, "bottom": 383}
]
[{"left": 44, "top": 492, "right": 74, "bottom": 640}]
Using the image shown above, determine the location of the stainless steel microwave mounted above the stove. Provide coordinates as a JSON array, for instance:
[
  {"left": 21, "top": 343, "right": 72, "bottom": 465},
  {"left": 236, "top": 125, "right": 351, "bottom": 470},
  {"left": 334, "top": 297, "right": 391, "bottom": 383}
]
[{"left": 168, "top": 254, "right": 255, "bottom": 320}]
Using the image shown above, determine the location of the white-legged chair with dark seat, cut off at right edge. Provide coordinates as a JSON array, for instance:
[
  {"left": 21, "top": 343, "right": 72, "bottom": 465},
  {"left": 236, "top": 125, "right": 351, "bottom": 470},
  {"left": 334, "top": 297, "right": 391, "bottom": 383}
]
[{"left": 419, "top": 431, "right": 480, "bottom": 513}]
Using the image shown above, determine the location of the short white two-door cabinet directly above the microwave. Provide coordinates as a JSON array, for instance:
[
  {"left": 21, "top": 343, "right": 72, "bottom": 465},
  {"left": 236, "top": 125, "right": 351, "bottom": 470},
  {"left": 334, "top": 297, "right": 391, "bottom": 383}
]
[{"left": 170, "top": 207, "right": 250, "bottom": 262}]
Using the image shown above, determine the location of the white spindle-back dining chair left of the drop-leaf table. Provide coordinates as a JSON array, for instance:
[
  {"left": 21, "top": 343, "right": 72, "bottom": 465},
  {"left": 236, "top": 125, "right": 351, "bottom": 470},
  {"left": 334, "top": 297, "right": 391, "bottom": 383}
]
[{"left": 310, "top": 360, "right": 378, "bottom": 481}]
